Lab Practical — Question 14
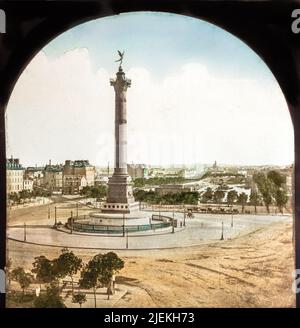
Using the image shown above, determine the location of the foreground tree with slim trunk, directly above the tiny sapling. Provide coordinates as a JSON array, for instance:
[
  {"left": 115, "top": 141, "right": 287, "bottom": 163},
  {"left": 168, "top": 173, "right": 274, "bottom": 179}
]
[{"left": 53, "top": 248, "right": 82, "bottom": 294}]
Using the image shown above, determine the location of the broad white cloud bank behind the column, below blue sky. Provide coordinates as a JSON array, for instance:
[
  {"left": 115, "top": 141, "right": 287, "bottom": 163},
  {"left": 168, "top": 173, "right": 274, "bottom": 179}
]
[{"left": 7, "top": 48, "right": 293, "bottom": 165}]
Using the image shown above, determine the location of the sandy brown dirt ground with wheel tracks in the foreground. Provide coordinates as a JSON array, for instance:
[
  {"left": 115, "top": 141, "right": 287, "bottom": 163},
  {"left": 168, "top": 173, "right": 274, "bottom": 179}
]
[{"left": 8, "top": 218, "right": 295, "bottom": 307}]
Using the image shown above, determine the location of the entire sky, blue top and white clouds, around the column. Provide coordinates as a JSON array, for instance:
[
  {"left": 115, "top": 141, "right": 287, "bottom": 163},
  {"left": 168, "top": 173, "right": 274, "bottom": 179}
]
[{"left": 6, "top": 13, "right": 294, "bottom": 166}]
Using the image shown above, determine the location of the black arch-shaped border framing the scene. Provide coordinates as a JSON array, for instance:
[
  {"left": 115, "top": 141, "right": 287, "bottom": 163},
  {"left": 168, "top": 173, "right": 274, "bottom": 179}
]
[{"left": 0, "top": 0, "right": 300, "bottom": 307}]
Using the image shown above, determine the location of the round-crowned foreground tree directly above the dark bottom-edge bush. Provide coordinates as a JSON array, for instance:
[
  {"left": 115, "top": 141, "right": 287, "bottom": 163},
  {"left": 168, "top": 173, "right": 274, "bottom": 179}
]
[{"left": 31, "top": 255, "right": 57, "bottom": 287}]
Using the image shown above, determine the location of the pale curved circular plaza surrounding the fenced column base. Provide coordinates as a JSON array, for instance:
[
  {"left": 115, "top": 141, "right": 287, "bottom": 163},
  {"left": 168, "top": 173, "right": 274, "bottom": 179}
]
[{"left": 7, "top": 212, "right": 292, "bottom": 250}]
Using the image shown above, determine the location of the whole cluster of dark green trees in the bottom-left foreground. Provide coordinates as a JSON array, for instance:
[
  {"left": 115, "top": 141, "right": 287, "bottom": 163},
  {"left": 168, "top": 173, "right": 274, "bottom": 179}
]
[{"left": 7, "top": 248, "right": 124, "bottom": 308}]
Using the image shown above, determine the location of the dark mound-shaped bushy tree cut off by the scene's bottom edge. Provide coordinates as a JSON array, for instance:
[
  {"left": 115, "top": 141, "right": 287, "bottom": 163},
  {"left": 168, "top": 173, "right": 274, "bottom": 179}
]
[{"left": 34, "top": 283, "right": 66, "bottom": 308}]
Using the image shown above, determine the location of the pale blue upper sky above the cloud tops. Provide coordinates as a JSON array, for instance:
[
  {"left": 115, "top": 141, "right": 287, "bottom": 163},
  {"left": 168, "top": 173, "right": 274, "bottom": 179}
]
[{"left": 44, "top": 13, "right": 273, "bottom": 83}]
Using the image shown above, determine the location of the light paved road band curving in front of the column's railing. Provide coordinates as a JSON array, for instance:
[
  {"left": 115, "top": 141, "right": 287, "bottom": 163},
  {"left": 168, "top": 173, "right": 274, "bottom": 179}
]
[{"left": 8, "top": 213, "right": 292, "bottom": 249}]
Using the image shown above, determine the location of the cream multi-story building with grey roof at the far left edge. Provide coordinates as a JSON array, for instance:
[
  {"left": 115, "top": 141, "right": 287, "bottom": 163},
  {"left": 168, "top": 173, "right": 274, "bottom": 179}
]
[{"left": 6, "top": 158, "right": 24, "bottom": 194}]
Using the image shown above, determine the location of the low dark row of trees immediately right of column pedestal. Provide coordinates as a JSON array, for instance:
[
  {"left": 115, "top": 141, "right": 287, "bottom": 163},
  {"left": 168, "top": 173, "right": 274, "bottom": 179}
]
[{"left": 134, "top": 190, "right": 199, "bottom": 205}]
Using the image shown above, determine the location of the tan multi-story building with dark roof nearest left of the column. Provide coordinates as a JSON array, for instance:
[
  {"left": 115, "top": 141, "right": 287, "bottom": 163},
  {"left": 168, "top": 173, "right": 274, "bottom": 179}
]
[{"left": 62, "top": 160, "right": 95, "bottom": 194}]
